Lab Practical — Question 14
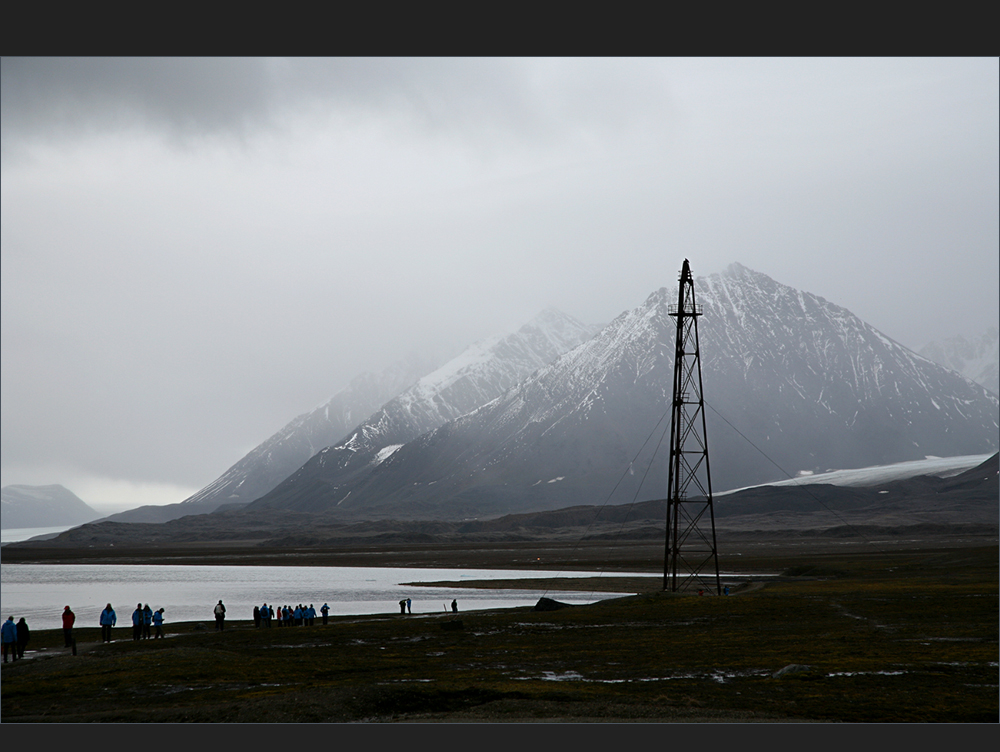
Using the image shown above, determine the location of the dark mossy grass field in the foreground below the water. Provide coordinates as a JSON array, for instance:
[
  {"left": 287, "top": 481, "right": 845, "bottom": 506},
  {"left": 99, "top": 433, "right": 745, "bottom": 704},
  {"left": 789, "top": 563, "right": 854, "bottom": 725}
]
[{"left": 0, "top": 545, "right": 1000, "bottom": 723}]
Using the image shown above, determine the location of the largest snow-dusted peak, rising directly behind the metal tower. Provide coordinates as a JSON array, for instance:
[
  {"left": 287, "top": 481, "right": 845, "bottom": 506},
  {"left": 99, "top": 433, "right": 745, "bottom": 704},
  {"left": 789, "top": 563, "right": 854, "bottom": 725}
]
[{"left": 250, "top": 264, "right": 1000, "bottom": 517}]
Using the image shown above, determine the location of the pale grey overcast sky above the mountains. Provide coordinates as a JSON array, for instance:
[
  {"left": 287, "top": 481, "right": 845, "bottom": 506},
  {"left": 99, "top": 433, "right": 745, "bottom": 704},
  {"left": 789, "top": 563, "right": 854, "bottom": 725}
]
[{"left": 0, "top": 58, "right": 1000, "bottom": 509}]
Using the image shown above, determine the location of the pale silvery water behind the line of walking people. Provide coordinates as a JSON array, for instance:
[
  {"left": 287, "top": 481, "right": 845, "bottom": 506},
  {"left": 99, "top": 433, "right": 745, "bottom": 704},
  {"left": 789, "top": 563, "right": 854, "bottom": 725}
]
[{"left": 0, "top": 564, "right": 621, "bottom": 629}]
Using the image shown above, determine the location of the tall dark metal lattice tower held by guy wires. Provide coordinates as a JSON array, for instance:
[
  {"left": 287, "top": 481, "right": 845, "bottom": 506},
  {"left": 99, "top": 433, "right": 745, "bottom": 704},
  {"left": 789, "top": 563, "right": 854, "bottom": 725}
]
[{"left": 663, "top": 259, "right": 722, "bottom": 595}]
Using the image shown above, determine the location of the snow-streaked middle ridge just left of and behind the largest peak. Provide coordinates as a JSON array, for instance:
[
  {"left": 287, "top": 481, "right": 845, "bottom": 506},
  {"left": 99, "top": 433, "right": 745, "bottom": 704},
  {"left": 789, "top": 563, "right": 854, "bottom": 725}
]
[{"left": 254, "top": 309, "right": 597, "bottom": 508}]
